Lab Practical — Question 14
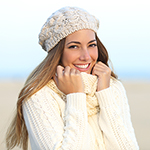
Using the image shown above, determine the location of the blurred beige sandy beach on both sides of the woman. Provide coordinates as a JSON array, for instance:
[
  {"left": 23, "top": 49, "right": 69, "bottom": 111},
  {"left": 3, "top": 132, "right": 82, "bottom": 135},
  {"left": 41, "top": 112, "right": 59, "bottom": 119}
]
[{"left": 0, "top": 81, "right": 150, "bottom": 150}]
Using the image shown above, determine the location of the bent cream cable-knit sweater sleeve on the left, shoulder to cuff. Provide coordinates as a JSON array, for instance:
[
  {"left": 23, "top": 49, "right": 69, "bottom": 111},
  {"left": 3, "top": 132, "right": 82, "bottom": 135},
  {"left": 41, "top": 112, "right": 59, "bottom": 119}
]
[{"left": 22, "top": 87, "right": 87, "bottom": 150}]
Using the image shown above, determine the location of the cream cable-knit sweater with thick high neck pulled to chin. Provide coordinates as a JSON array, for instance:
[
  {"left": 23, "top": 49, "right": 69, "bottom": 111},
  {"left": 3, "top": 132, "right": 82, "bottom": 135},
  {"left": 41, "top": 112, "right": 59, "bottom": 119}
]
[{"left": 22, "top": 73, "right": 139, "bottom": 150}]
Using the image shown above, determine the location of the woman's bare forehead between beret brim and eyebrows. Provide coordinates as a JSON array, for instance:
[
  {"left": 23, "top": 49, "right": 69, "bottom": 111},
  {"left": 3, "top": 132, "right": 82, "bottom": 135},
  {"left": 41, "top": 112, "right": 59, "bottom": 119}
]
[{"left": 66, "top": 29, "right": 95, "bottom": 43}]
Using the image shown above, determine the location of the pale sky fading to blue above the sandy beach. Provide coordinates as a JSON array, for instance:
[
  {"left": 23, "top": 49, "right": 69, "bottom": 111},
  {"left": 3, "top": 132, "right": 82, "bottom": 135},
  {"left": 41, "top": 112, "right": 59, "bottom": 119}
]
[{"left": 0, "top": 0, "right": 150, "bottom": 78}]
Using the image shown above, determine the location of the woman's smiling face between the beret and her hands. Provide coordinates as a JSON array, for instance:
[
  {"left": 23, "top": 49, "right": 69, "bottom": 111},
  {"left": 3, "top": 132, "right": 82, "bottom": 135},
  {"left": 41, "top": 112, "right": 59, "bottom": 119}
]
[{"left": 61, "top": 29, "right": 98, "bottom": 74}]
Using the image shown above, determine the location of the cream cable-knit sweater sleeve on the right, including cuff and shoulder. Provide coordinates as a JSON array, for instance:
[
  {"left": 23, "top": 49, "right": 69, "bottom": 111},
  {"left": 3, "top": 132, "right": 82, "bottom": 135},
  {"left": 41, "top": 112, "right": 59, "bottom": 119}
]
[{"left": 96, "top": 80, "right": 139, "bottom": 150}]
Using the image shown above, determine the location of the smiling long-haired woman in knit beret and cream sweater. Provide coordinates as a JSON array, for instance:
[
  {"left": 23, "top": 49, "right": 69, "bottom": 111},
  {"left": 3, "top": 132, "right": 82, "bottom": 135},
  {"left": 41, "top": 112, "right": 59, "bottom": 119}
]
[{"left": 6, "top": 7, "right": 138, "bottom": 150}]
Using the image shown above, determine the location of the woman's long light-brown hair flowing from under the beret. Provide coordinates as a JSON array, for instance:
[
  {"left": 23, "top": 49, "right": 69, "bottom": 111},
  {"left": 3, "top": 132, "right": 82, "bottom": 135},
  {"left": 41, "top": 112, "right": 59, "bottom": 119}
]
[{"left": 6, "top": 35, "right": 116, "bottom": 150}]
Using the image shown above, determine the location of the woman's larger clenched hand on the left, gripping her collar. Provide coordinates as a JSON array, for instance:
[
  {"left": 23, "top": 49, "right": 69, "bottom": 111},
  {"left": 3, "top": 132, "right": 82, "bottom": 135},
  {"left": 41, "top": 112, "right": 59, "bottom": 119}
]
[{"left": 54, "top": 65, "right": 84, "bottom": 95}]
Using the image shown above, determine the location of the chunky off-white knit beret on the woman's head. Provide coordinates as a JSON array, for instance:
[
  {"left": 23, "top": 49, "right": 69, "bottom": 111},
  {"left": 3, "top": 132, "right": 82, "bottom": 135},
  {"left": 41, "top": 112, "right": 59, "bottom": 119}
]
[{"left": 39, "top": 7, "right": 99, "bottom": 52}]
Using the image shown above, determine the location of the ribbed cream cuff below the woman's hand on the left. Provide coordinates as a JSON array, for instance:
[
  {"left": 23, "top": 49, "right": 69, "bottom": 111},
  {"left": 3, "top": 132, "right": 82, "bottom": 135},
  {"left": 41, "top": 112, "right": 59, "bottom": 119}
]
[{"left": 66, "top": 93, "right": 86, "bottom": 110}]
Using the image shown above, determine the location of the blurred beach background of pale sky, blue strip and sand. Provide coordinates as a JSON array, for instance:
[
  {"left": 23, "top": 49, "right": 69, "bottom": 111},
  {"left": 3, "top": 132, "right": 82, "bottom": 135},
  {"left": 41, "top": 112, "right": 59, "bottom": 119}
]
[{"left": 0, "top": 0, "right": 150, "bottom": 150}]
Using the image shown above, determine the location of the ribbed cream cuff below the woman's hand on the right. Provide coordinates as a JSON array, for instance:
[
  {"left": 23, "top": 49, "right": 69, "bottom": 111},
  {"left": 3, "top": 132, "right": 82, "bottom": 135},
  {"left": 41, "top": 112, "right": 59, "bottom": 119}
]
[{"left": 95, "top": 87, "right": 116, "bottom": 107}]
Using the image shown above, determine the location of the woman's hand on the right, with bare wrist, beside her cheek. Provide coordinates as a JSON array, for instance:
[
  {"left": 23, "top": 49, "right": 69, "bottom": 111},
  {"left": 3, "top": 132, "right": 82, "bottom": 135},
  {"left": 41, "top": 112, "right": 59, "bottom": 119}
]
[{"left": 92, "top": 62, "right": 111, "bottom": 91}]
